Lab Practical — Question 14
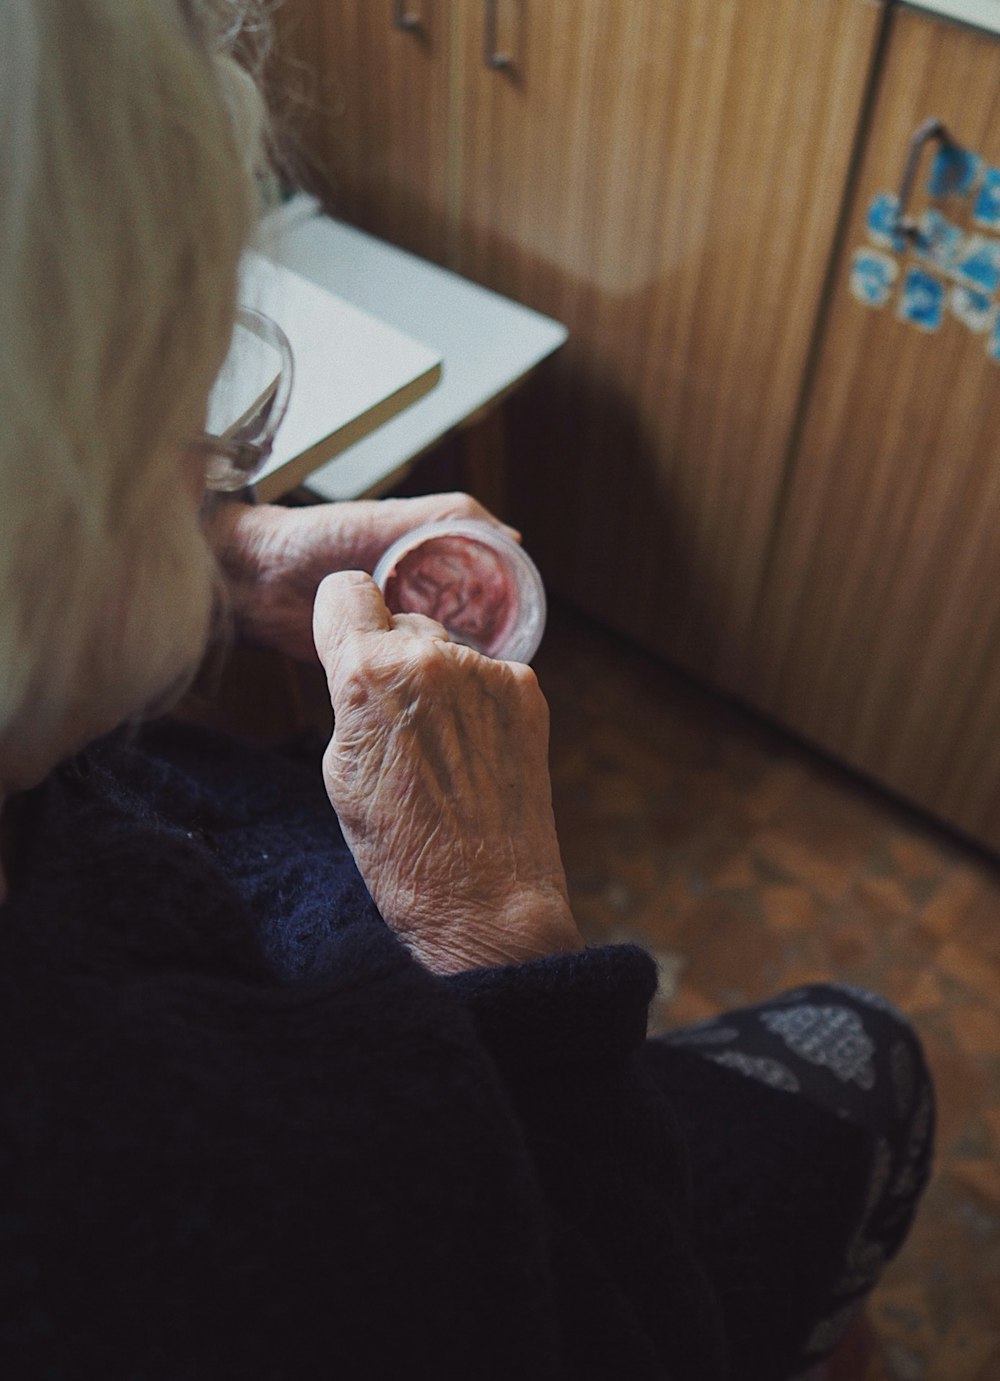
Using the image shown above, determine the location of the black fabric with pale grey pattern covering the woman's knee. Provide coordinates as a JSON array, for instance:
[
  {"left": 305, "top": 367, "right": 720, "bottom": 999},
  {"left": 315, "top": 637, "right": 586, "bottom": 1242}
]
[{"left": 651, "top": 983, "right": 934, "bottom": 1378}]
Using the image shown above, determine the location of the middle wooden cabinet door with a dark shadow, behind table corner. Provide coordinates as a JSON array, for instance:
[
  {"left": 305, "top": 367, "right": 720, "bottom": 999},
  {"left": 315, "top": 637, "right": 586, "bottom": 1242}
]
[{"left": 454, "top": 0, "right": 884, "bottom": 686}]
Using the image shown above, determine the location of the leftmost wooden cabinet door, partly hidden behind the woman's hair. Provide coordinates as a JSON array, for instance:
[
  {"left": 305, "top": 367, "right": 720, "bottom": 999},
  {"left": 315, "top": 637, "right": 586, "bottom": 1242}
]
[{"left": 278, "top": 0, "right": 456, "bottom": 262}]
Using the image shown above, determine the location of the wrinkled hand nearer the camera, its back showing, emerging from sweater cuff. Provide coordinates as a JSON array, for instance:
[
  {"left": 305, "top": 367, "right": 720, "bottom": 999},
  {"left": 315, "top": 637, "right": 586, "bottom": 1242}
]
[{"left": 315, "top": 572, "right": 583, "bottom": 974}]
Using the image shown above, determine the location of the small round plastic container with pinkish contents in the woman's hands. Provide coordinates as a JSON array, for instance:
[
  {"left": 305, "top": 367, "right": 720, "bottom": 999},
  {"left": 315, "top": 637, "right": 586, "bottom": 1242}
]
[{"left": 374, "top": 518, "right": 546, "bottom": 661}]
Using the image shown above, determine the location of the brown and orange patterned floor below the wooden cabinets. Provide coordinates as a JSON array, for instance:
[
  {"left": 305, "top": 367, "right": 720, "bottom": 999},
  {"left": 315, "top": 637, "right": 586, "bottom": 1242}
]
[{"left": 536, "top": 610, "right": 1000, "bottom": 1381}]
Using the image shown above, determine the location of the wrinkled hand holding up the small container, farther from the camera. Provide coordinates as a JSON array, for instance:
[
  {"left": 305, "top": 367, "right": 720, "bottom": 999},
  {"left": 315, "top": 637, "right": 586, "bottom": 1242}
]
[{"left": 206, "top": 493, "right": 512, "bottom": 661}]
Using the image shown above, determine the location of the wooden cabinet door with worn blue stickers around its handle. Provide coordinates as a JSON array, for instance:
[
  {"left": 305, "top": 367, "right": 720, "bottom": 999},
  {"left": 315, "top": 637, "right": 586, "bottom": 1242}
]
[{"left": 750, "top": 10, "right": 1000, "bottom": 848}]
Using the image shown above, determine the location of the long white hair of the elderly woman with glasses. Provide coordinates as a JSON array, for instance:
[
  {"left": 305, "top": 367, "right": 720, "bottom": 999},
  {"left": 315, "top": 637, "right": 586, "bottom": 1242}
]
[{"left": 0, "top": 0, "right": 269, "bottom": 778}]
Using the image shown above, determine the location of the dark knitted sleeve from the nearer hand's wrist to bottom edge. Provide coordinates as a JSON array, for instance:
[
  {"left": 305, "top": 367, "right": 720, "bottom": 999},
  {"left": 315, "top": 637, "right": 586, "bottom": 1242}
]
[{"left": 446, "top": 945, "right": 725, "bottom": 1381}]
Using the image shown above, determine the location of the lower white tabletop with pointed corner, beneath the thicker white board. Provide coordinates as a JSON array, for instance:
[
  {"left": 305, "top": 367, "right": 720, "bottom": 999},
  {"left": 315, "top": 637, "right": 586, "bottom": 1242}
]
[{"left": 258, "top": 195, "right": 566, "bottom": 511}]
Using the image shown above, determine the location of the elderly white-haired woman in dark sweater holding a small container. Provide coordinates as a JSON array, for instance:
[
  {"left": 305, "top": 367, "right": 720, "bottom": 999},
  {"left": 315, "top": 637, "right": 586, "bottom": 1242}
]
[{"left": 0, "top": 0, "right": 931, "bottom": 1381}]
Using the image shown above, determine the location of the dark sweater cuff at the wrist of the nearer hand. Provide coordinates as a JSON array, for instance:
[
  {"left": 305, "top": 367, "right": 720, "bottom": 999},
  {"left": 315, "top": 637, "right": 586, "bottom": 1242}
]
[{"left": 442, "top": 945, "right": 656, "bottom": 1074}]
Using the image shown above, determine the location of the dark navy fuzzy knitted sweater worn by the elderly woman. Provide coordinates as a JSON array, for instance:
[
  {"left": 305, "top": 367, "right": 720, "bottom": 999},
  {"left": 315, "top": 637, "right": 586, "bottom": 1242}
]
[{"left": 0, "top": 724, "right": 722, "bottom": 1381}]
